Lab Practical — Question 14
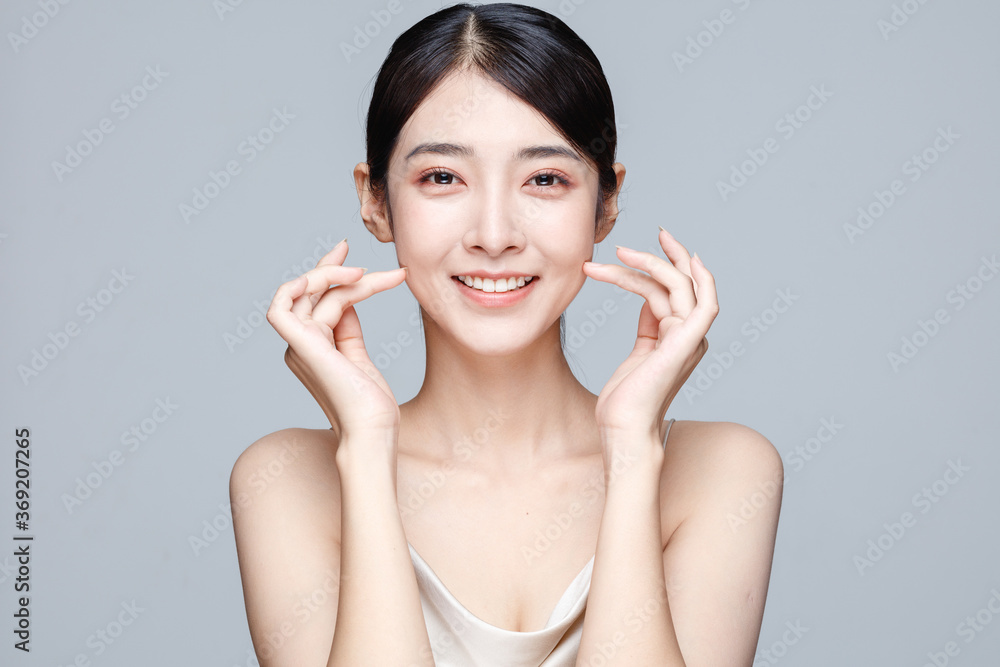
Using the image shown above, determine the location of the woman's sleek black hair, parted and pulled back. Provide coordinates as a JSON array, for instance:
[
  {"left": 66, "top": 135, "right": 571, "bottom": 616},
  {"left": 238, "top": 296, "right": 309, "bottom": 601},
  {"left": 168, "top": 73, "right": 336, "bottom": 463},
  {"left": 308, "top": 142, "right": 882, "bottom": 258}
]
[{"left": 365, "top": 3, "right": 617, "bottom": 225}]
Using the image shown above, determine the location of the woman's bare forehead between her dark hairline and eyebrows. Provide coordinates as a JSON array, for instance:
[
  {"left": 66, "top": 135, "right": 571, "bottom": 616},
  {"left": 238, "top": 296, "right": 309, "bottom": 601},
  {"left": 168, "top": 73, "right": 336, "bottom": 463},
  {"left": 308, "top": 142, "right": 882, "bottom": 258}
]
[{"left": 397, "top": 70, "right": 570, "bottom": 155}]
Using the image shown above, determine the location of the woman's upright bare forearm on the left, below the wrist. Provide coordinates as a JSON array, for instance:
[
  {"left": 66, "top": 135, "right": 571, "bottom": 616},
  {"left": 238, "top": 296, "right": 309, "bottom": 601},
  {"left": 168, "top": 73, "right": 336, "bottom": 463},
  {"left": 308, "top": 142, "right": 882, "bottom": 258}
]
[{"left": 328, "top": 442, "right": 434, "bottom": 667}]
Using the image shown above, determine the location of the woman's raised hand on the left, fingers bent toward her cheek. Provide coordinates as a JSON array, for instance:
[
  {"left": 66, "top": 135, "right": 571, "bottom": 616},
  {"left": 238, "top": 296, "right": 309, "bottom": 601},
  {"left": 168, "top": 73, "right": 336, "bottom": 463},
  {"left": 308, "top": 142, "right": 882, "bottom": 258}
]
[{"left": 267, "top": 239, "right": 406, "bottom": 442}]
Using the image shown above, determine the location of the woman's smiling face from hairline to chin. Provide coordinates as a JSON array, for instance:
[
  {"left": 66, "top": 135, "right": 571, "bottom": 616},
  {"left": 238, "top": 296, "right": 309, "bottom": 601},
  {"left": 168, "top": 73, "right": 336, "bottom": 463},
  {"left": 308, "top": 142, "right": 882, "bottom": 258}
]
[{"left": 376, "top": 72, "right": 608, "bottom": 355}]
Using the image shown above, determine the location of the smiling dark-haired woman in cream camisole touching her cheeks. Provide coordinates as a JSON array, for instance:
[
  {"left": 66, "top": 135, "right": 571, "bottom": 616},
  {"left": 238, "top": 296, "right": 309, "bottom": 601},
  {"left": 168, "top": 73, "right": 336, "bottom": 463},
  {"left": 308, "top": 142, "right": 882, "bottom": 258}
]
[{"left": 230, "top": 4, "right": 782, "bottom": 667}]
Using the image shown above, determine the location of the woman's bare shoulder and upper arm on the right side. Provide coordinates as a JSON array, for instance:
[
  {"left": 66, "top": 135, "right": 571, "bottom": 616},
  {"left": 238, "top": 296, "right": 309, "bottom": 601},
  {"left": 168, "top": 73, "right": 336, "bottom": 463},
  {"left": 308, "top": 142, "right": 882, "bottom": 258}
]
[{"left": 660, "top": 421, "right": 784, "bottom": 665}]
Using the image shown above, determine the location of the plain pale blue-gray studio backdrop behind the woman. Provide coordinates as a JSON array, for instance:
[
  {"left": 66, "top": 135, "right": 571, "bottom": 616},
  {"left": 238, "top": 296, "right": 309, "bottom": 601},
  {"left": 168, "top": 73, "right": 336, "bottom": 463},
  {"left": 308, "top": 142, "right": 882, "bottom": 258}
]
[{"left": 0, "top": 0, "right": 1000, "bottom": 667}]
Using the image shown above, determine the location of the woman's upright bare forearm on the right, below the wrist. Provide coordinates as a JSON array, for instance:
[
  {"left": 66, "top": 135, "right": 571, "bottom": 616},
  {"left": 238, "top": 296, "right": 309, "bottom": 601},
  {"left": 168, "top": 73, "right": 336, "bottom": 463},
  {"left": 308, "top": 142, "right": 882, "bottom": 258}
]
[{"left": 576, "top": 443, "right": 684, "bottom": 667}]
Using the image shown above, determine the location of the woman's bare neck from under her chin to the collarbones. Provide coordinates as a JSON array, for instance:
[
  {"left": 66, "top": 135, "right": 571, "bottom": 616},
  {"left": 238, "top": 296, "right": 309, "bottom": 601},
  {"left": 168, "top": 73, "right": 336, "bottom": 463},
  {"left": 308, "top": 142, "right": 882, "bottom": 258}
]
[{"left": 400, "top": 318, "right": 597, "bottom": 470}]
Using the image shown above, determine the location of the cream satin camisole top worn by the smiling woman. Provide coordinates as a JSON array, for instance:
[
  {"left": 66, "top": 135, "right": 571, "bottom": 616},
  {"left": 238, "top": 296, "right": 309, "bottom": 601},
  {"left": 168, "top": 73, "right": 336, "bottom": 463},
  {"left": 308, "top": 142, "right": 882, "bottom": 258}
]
[{"left": 407, "top": 419, "right": 674, "bottom": 667}]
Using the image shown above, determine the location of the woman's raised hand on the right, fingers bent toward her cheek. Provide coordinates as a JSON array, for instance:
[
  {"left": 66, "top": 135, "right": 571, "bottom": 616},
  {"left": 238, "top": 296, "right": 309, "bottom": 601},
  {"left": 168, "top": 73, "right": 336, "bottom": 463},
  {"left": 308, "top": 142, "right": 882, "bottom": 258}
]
[{"left": 583, "top": 230, "right": 719, "bottom": 450}]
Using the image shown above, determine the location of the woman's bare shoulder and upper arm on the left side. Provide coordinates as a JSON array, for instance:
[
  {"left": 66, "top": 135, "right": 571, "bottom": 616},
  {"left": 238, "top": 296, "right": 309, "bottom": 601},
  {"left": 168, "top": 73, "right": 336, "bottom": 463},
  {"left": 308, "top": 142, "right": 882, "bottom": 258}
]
[{"left": 229, "top": 428, "right": 340, "bottom": 667}]
